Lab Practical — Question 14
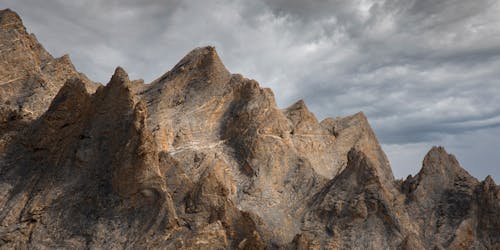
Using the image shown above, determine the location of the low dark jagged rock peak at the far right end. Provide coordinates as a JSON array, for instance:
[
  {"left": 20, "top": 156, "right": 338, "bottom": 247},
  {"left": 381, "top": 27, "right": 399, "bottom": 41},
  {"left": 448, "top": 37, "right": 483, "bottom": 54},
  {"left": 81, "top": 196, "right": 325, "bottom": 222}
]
[{"left": 401, "top": 147, "right": 500, "bottom": 249}]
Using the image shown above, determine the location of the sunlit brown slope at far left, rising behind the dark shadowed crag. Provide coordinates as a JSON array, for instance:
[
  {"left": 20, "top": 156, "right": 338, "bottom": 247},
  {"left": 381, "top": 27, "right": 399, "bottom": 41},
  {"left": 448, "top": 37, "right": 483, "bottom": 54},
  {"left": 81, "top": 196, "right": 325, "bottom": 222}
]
[{"left": 0, "top": 9, "right": 95, "bottom": 123}]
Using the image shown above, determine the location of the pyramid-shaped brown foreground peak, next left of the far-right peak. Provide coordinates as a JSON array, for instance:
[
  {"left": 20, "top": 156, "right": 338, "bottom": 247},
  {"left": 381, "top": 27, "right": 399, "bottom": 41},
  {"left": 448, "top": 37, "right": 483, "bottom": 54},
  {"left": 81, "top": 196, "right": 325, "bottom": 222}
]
[{"left": 303, "top": 149, "right": 412, "bottom": 249}]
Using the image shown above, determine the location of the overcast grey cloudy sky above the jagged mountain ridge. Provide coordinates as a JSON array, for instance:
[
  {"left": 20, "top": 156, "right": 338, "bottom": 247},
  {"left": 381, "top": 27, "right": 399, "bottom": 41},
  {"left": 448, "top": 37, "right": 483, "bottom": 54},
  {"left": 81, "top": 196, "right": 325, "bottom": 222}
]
[{"left": 0, "top": 0, "right": 500, "bottom": 183}]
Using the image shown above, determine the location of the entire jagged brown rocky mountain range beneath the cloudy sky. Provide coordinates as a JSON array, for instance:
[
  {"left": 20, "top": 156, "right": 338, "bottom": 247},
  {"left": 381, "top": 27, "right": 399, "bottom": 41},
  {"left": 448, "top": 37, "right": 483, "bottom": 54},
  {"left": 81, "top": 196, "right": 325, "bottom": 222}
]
[{"left": 0, "top": 10, "right": 500, "bottom": 249}]
